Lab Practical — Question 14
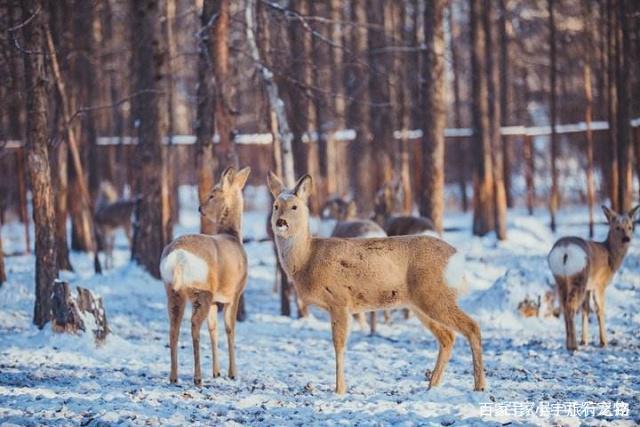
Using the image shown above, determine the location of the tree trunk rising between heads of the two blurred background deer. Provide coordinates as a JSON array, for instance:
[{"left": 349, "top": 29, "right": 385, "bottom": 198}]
[{"left": 345, "top": 0, "right": 374, "bottom": 212}]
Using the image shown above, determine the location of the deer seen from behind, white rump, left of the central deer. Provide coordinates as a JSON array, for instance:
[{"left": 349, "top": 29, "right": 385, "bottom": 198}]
[{"left": 160, "top": 167, "right": 251, "bottom": 385}]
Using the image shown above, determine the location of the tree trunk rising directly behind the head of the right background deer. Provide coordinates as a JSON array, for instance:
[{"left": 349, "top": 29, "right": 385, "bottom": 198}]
[{"left": 366, "top": 0, "right": 397, "bottom": 188}]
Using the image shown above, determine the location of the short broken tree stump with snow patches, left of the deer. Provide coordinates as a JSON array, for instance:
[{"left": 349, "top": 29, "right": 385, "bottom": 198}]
[{"left": 51, "top": 280, "right": 110, "bottom": 344}]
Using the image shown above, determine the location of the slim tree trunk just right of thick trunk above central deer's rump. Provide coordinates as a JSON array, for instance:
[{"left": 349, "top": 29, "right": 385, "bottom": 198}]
[{"left": 449, "top": 3, "right": 469, "bottom": 212}]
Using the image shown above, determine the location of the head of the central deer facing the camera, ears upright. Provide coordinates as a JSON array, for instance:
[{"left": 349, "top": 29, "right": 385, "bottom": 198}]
[{"left": 267, "top": 172, "right": 313, "bottom": 238}]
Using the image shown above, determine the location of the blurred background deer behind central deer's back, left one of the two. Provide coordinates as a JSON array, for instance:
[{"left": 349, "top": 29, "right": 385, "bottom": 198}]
[{"left": 321, "top": 197, "right": 384, "bottom": 335}]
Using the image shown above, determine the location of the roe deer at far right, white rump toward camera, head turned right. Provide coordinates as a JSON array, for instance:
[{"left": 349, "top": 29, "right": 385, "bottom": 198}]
[{"left": 548, "top": 206, "right": 640, "bottom": 352}]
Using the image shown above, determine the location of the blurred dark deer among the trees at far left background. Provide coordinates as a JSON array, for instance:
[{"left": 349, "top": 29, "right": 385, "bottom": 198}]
[{"left": 94, "top": 181, "right": 139, "bottom": 268}]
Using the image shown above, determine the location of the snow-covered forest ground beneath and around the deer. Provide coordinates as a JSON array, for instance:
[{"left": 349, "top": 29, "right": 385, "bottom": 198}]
[{"left": 0, "top": 189, "right": 640, "bottom": 426}]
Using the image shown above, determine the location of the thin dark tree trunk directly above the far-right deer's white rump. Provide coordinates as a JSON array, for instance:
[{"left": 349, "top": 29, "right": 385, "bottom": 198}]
[{"left": 547, "top": 0, "right": 559, "bottom": 232}]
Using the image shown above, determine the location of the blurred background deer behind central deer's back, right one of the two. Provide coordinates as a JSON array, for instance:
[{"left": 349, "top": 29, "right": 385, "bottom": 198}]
[{"left": 373, "top": 183, "right": 435, "bottom": 236}]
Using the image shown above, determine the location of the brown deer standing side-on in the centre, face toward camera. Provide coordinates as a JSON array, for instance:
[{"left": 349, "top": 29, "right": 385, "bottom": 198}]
[{"left": 268, "top": 173, "right": 485, "bottom": 394}]
